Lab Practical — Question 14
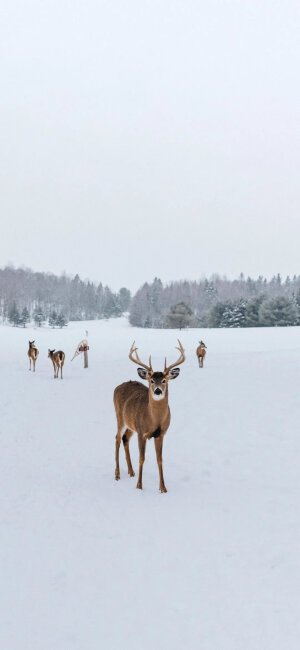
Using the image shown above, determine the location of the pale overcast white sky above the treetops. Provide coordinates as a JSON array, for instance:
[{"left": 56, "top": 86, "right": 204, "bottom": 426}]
[{"left": 0, "top": 0, "right": 300, "bottom": 290}]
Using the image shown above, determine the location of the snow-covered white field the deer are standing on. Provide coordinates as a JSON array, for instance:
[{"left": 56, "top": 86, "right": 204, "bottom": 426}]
[{"left": 0, "top": 319, "right": 300, "bottom": 650}]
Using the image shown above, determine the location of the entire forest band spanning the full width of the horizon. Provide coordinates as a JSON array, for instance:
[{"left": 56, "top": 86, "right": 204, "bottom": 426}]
[{"left": 0, "top": 266, "right": 300, "bottom": 328}]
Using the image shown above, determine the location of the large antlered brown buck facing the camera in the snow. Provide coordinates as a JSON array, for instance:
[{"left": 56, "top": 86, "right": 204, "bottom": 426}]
[{"left": 114, "top": 339, "right": 185, "bottom": 492}]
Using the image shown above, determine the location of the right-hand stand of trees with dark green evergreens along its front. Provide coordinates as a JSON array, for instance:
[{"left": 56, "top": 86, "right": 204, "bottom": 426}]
[{"left": 130, "top": 274, "right": 300, "bottom": 328}]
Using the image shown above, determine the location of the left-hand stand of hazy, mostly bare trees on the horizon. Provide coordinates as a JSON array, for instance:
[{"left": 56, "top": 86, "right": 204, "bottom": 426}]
[{"left": 0, "top": 266, "right": 131, "bottom": 327}]
